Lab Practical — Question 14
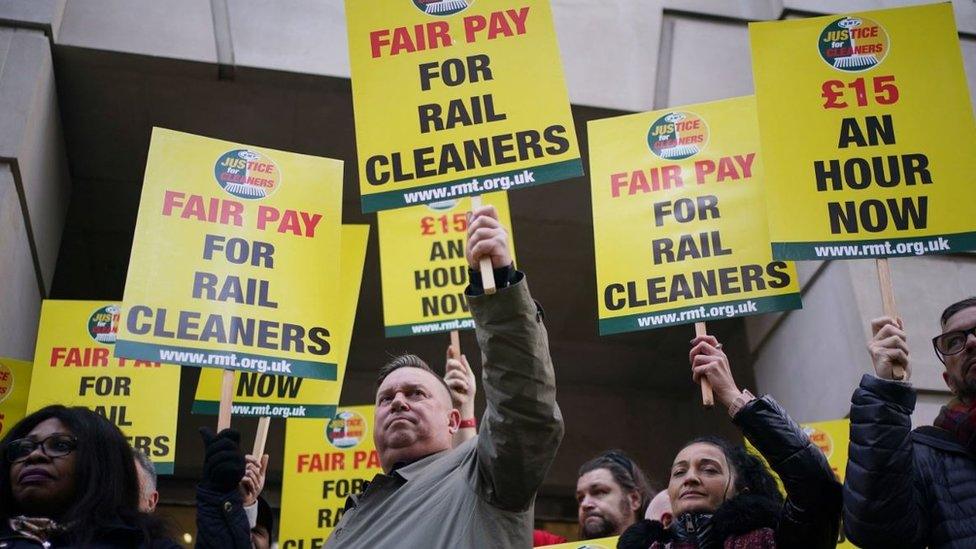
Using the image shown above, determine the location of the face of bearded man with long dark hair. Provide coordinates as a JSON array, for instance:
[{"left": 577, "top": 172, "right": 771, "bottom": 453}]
[{"left": 576, "top": 469, "right": 640, "bottom": 539}]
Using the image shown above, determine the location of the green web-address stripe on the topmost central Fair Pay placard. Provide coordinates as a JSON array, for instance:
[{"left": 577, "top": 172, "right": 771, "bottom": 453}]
[{"left": 361, "top": 158, "right": 583, "bottom": 213}]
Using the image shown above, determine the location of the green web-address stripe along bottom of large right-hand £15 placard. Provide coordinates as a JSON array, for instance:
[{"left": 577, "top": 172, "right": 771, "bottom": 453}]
[{"left": 772, "top": 232, "right": 976, "bottom": 261}]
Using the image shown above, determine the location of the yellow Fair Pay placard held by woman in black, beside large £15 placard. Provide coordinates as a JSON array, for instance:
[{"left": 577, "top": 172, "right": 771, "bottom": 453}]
[{"left": 588, "top": 97, "right": 800, "bottom": 334}]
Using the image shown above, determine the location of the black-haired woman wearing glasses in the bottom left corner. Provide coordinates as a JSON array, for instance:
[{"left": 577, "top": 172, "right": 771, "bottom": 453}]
[{"left": 0, "top": 406, "right": 179, "bottom": 549}]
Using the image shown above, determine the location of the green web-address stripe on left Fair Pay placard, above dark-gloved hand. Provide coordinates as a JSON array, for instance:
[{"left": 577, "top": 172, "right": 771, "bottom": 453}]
[{"left": 115, "top": 339, "right": 339, "bottom": 381}]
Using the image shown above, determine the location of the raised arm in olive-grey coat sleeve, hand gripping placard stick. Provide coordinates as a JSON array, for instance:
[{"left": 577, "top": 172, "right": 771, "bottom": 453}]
[{"left": 467, "top": 206, "right": 563, "bottom": 511}]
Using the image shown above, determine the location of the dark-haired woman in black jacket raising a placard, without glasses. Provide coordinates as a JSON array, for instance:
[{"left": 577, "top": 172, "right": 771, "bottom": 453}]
[{"left": 617, "top": 336, "right": 841, "bottom": 549}]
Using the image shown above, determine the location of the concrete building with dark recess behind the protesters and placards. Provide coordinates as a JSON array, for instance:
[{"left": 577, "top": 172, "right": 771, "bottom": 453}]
[{"left": 0, "top": 0, "right": 976, "bottom": 536}]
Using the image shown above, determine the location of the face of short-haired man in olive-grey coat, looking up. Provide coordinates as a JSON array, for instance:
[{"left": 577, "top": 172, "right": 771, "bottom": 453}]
[{"left": 373, "top": 367, "right": 461, "bottom": 471}]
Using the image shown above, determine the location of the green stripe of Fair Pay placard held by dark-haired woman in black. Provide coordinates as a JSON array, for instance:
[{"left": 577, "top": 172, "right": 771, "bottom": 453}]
[{"left": 600, "top": 293, "right": 803, "bottom": 335}]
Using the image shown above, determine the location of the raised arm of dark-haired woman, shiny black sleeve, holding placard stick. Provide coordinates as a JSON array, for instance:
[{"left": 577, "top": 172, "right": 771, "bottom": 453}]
[{"left": 690, "top": 336, "right": 841, "bottom": 548}]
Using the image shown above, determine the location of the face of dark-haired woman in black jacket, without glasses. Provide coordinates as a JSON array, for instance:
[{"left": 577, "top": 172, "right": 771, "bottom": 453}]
[{"left": 668, "top": 442, "right": 735, "bottom": 517}]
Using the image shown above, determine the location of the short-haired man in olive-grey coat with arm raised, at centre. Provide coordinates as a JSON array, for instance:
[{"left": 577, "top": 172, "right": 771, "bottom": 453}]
[{"left": 325, "top": 206, "right": 563, "bottom": 549}]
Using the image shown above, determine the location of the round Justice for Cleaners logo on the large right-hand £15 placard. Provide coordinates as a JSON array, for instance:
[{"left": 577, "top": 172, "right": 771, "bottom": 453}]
[{"left": 817, "top": 17, "right": 891, "bottom": 72}]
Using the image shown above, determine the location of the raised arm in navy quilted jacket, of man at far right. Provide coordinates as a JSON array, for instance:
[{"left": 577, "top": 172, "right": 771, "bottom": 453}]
[{"left": 844, "top": 317, "right": 928, "bottom": 547}]
